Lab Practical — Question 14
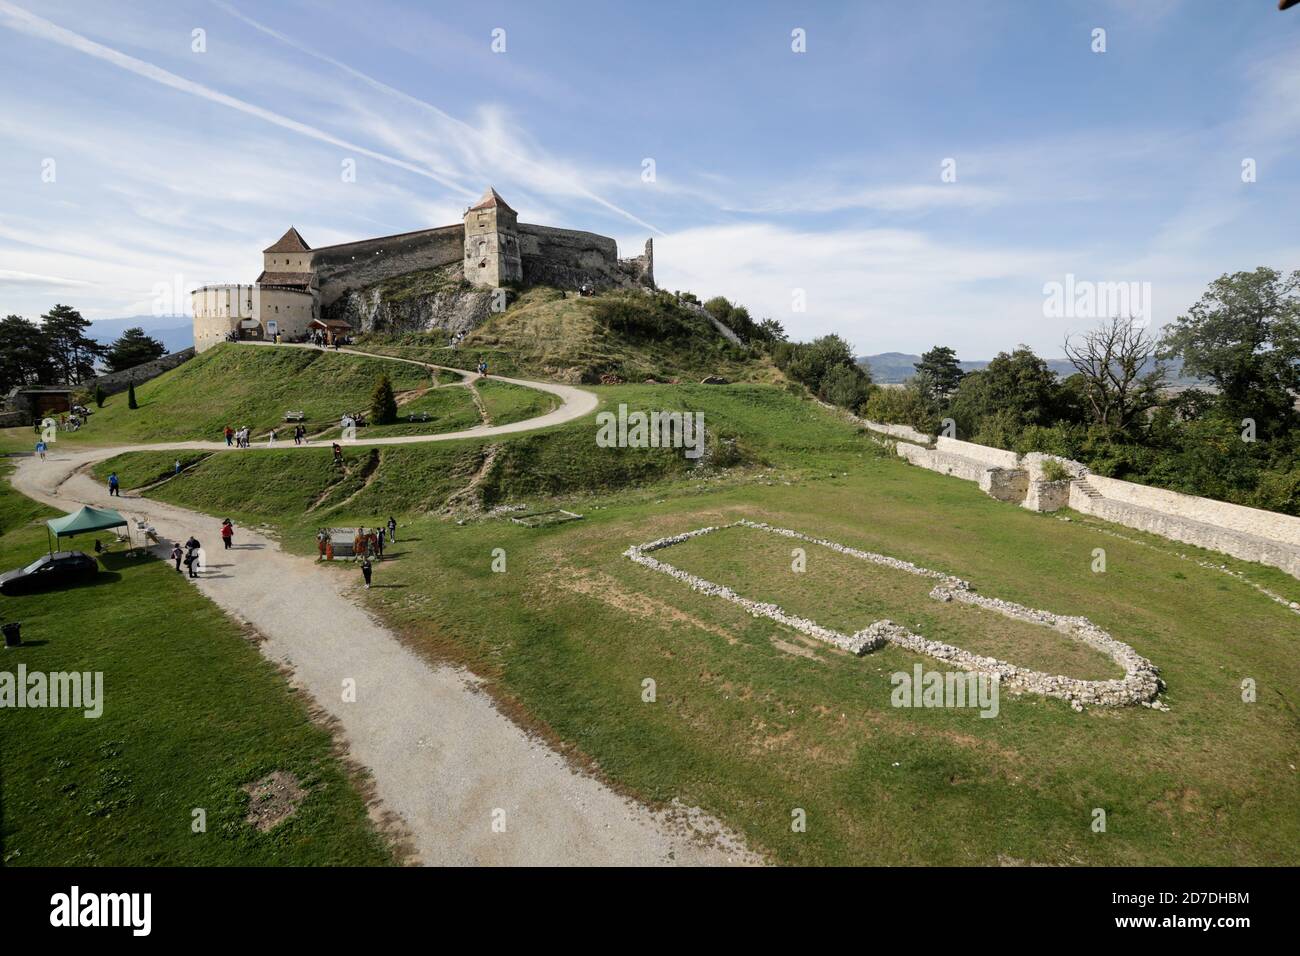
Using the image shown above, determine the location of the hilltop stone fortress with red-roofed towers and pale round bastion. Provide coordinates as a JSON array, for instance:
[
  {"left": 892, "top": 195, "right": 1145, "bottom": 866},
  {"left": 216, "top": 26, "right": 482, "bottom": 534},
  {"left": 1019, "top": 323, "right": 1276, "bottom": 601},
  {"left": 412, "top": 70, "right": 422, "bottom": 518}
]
[{"left": 191, "top": 187, "right": 654, "bottom": 352}]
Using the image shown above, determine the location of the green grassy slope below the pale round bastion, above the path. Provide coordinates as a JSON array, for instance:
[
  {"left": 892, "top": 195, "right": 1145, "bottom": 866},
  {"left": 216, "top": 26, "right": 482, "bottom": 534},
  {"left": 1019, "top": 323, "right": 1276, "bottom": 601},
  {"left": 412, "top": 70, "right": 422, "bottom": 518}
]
[{"left": 59, "top": 343, "right": 429, "bottom": 445}]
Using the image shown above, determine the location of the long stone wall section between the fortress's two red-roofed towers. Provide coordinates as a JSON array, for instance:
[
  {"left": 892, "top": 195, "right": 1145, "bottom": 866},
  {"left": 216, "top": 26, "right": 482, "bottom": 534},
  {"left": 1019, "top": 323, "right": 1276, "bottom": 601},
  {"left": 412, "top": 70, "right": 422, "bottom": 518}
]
[{"left": 312, "top": 222, "right": 465, "bottom": 308}]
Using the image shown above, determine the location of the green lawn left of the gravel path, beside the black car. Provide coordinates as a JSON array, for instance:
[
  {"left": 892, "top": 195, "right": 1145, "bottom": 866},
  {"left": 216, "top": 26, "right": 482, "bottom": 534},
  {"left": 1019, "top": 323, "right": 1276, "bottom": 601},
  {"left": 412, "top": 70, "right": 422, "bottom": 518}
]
[{"left": 0, "top": 468, "right": 391, "bottom": 866}]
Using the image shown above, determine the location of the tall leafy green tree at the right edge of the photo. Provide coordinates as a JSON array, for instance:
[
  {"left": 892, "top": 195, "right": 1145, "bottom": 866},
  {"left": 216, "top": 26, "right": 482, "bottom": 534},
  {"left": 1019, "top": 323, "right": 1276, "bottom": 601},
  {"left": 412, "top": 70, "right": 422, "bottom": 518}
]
[{"left": 1160, "top": 267, "right": 1300, "bottom": 434}]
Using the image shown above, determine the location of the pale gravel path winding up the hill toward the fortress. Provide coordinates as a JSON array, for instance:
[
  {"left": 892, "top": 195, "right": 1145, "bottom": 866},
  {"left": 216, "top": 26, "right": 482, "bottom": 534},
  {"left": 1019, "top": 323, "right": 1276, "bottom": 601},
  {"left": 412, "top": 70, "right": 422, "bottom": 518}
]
[{"left": 13, "top": 346, "right": 759, "bottom": 865}]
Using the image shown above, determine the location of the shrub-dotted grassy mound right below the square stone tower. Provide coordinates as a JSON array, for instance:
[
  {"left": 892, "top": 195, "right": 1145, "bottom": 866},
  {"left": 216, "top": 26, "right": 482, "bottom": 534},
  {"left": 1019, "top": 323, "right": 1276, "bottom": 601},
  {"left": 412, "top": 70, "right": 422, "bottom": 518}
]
[{"left": 361, "top": 289, "right": 783, "bottom": 384}]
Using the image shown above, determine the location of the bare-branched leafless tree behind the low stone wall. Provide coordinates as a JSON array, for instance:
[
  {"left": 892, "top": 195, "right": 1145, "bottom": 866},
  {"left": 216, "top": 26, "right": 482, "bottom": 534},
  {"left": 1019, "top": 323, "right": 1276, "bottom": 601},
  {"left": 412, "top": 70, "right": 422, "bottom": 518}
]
[{"left": 1065, "top": 317, "right": 1166, "bottom": 434}]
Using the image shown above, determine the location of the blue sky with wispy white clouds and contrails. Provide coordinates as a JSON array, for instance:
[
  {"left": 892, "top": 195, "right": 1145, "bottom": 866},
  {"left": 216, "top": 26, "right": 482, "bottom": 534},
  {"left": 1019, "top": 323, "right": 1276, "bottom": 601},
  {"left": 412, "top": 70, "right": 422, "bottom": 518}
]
[{"left": 0, "top": 0, "right": 1300, "bottom": 359}]
